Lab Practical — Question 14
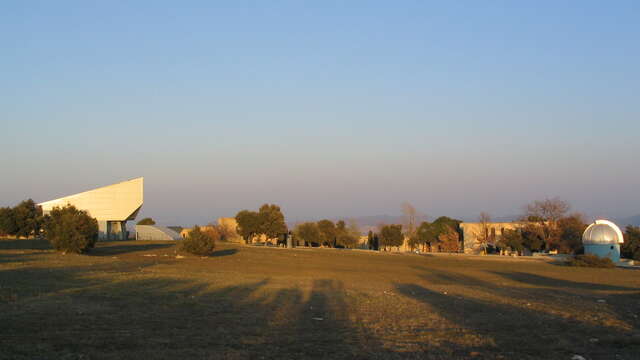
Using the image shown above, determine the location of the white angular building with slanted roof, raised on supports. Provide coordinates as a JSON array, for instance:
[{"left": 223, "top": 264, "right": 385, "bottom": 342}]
[{"left": 38, "top": 177, "right": 144, "bottom": 240}]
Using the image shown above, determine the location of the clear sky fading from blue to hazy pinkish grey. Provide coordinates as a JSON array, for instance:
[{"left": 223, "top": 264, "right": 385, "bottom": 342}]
[{"left": 0, "top": 0, "right": 640, "bottom": 225}]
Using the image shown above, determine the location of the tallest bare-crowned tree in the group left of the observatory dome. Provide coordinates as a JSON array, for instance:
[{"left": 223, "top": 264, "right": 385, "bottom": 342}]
[{"left": 523, "top": 197, "right": 570, "bottom": 250}]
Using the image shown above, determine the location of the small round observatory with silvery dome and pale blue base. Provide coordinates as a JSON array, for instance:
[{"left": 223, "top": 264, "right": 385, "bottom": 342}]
[{"left": 582, "top": 220, "right": 624, "bottom": 262}]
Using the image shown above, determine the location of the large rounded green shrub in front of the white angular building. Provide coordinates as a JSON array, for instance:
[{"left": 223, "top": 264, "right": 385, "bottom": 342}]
[{"left": 45, "top": 205, "right": 98, "bottom": 254}]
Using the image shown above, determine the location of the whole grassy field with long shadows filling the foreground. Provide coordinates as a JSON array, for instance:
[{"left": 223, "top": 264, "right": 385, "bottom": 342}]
[{"left": 0, "top": 240, "right": 640, "bottom": 359}]
